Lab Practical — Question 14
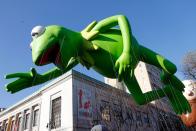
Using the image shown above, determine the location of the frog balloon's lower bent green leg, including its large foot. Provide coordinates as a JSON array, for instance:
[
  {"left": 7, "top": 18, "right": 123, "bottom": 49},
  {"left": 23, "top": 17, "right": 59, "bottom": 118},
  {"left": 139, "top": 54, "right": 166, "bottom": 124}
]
[{"left": 124, "top": 76, "right": 191, "bottom": 114}]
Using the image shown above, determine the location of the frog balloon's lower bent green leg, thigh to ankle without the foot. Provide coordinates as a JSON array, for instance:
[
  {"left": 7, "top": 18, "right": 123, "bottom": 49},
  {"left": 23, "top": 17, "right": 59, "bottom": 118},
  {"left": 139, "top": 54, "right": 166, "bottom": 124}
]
[{"left": 124, "top": 75, "right": 165, "bottom": 105}]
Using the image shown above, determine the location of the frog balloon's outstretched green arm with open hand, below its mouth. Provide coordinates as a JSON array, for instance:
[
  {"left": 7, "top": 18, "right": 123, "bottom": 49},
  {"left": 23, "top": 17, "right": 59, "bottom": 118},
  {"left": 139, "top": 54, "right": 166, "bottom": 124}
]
[{"left": 5, "top": 59, "right": 78, "bottom": 93}]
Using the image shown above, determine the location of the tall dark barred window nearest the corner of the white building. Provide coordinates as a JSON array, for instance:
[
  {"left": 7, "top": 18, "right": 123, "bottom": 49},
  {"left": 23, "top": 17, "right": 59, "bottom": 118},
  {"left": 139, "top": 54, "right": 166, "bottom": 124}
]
[{"left": 50, "top": 97, "right": 61, "bottom": 129}]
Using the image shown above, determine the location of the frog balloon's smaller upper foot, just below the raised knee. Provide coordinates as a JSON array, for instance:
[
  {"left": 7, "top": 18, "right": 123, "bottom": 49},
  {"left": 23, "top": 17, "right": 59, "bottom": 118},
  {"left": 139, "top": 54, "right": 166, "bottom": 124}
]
[{"left": 160, "top": 71, "right": 185, "bottom": 91}]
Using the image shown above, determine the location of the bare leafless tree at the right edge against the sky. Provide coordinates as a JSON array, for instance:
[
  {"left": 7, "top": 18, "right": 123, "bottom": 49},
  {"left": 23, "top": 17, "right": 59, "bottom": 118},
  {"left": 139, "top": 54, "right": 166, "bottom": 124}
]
[{"left": 182, "top": 51, "right": 196, "bottom": 80}]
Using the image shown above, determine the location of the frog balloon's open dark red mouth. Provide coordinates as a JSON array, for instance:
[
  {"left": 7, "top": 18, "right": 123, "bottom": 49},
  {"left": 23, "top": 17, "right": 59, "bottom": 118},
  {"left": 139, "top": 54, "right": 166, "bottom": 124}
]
[{"left": 38, "top": 44, "right": 61, "bottom": 65}]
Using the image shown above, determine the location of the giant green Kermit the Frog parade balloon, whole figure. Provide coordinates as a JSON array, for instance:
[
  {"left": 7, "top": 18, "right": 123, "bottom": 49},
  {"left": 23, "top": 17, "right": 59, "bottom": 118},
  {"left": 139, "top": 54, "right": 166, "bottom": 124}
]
[{"left": 6, "top": 15, "right": 191, "bottom": 114}]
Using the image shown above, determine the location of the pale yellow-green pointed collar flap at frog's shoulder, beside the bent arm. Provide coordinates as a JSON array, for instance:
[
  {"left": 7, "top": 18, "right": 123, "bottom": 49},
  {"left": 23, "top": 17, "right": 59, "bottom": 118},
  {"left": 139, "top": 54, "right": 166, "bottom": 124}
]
[{"left": 81, "top": 21, "right": 99, "bottom": 40}]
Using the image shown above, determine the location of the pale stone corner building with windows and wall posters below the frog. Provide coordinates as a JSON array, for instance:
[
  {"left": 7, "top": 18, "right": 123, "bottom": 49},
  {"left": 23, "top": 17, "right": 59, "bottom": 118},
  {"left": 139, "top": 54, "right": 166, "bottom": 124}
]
[{"left": 0, "top": 70, "right": 186, "bottom": 131}]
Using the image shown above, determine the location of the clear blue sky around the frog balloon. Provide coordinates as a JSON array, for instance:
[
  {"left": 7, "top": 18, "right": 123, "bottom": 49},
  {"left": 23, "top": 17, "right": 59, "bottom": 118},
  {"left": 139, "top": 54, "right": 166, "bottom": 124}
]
[{"left": 0, "top": 0, "right": 196, "bottom": 107}]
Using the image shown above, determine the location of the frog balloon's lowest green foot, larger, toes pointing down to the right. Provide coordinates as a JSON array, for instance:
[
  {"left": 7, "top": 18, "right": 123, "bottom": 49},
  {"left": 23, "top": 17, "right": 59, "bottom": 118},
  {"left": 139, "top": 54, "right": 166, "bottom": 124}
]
[{"left": 164, "top": 85, "right": 191, "bottom": 114}]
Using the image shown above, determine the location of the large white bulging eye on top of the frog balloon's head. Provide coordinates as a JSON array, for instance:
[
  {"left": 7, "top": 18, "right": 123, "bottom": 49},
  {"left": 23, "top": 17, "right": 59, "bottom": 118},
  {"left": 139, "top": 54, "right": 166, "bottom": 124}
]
[{"left": 31, "top": 26, "right": 46, "bottom": 38}]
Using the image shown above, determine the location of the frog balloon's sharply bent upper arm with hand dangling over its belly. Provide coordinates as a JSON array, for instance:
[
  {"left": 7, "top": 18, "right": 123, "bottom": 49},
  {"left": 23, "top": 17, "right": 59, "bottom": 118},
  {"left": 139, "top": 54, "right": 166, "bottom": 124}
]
[{"left": 92, "top": 15, "right": 133, "bottom": 80}]
